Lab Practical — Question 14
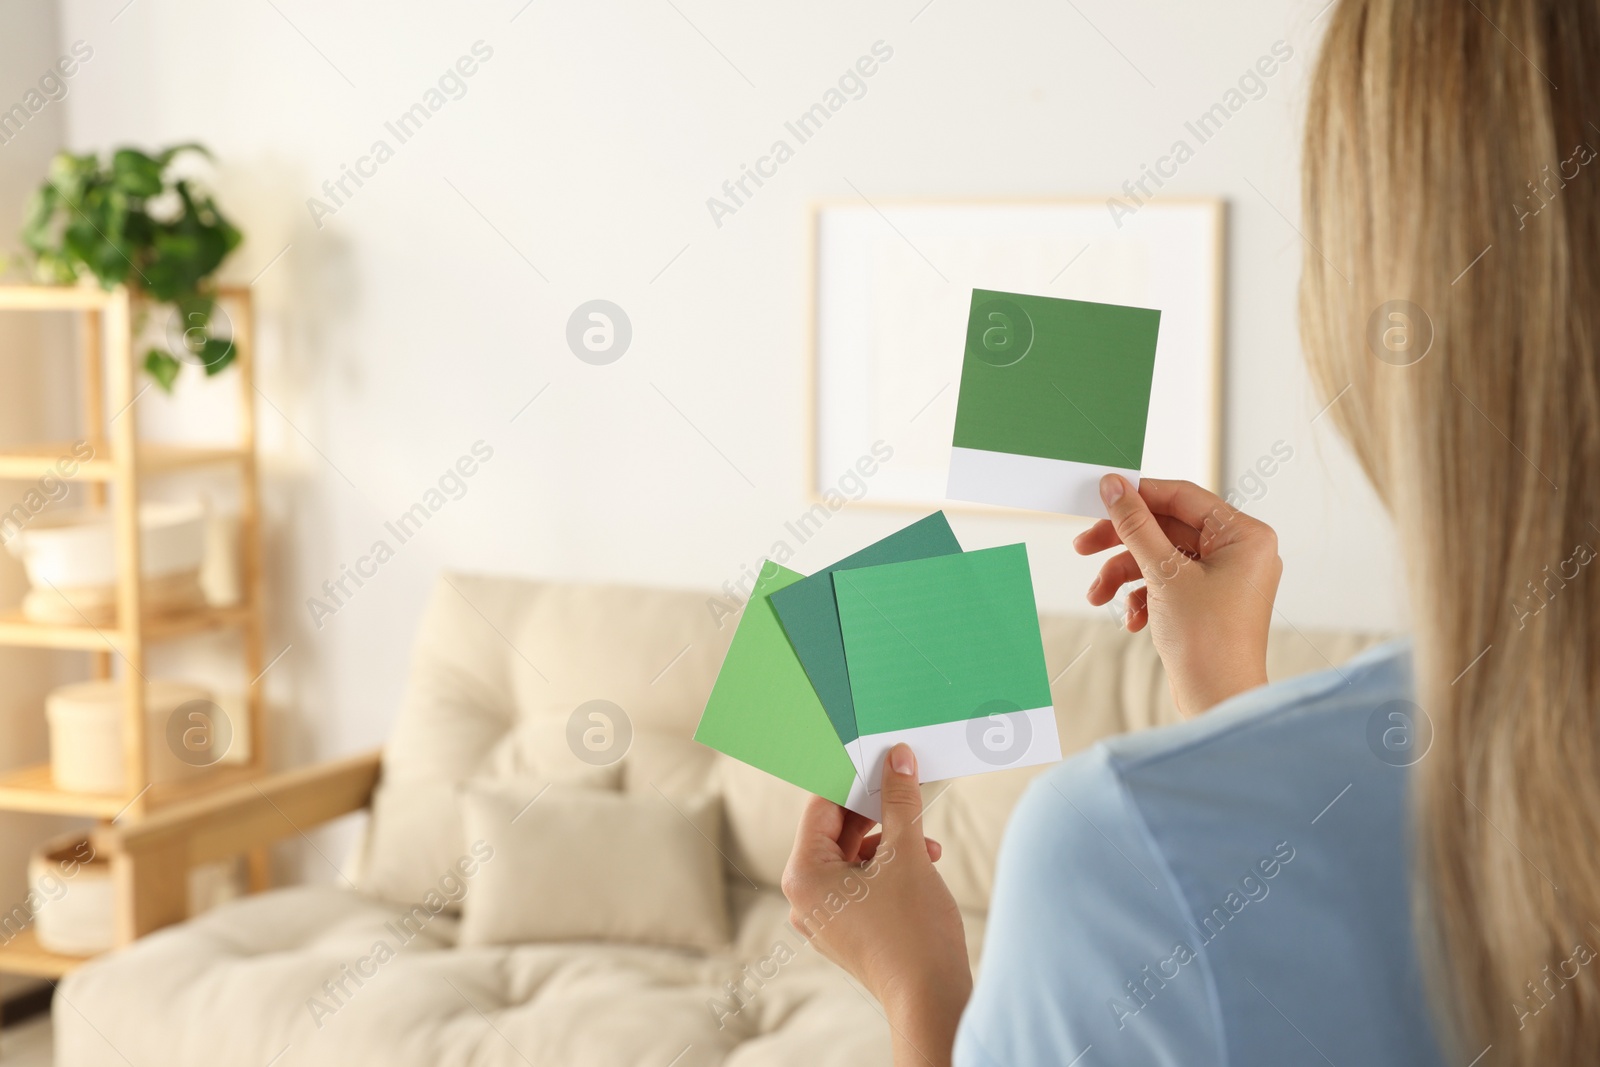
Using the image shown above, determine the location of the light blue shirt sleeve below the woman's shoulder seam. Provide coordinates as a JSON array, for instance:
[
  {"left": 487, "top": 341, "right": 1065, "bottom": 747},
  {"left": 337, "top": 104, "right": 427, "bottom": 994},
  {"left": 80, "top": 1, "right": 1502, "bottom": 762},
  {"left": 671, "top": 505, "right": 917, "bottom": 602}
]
[{"left": 955, "top": 747, "right": 1226, "bottom": 1067}]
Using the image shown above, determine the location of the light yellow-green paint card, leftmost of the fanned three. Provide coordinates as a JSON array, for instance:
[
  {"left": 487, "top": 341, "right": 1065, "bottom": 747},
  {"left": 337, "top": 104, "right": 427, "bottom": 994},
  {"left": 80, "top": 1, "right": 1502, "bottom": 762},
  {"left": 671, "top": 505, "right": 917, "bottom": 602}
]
[{"left": 694, "top": 563, "right": 856, "bottom": 805}]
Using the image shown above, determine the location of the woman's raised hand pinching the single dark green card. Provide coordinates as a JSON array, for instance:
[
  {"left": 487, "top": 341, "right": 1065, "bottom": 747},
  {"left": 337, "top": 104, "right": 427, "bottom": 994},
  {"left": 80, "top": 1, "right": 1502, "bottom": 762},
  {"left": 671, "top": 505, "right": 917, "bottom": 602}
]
[{"left": 1072, "top": 474, "right": 1283, "bottom": 715}]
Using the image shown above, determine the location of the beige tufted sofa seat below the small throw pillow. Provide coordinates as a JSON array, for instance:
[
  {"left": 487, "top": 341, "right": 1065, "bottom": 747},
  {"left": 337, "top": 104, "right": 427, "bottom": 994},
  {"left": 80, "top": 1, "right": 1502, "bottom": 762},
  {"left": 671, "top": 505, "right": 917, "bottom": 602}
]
[{"left": 53, "top": 888, "right": 890, "bottom": 1067}]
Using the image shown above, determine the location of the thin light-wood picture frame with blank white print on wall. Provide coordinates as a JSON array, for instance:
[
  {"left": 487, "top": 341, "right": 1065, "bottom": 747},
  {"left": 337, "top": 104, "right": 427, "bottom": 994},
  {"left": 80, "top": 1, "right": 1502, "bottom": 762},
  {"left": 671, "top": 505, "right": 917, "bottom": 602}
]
[{"left": 808, "top": 197, "right": 1226, "bottom": 512}]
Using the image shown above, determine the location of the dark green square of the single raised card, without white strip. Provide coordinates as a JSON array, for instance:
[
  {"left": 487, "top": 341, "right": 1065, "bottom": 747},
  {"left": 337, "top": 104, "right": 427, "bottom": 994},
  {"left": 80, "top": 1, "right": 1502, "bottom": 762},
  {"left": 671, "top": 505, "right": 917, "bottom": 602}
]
[{"left": 954, "top": 290, "right": 1162, "bottom": 470}]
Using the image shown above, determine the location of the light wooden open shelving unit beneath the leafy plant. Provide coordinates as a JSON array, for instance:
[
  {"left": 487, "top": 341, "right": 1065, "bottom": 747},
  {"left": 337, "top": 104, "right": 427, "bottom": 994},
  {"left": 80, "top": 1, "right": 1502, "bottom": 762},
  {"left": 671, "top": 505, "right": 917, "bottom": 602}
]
[{"left": 0, "top": 286, "right": 267, "bottom": 977}]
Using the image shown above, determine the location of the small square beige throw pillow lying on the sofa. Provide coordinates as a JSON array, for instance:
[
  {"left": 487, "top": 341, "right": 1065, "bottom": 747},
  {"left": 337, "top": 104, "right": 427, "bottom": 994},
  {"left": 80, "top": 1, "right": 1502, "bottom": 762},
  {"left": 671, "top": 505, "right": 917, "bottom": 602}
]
[{"left": 461, "top": 785, "right": 728, "bottom": 949}]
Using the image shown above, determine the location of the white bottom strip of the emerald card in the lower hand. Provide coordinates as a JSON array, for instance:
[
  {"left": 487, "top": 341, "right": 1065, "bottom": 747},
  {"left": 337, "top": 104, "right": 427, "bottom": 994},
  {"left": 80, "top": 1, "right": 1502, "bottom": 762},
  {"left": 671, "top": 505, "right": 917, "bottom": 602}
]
[{"left": 846, "top": 707, "right": 1061, "bottom": 796}]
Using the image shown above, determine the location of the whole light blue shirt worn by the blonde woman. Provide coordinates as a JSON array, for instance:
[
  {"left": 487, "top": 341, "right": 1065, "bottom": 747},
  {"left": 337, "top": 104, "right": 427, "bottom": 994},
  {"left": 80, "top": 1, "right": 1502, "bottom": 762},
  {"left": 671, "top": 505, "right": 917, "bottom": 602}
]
[{"left": 955, "top": 645, "right": 1443, "bottom": 1067}]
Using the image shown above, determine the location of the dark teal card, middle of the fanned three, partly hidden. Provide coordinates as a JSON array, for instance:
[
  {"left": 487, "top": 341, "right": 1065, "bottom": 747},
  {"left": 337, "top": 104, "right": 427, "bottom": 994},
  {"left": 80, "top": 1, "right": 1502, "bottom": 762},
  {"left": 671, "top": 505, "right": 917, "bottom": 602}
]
[{"left": 773, "top": 512, "right": 962, "bottom": 744}]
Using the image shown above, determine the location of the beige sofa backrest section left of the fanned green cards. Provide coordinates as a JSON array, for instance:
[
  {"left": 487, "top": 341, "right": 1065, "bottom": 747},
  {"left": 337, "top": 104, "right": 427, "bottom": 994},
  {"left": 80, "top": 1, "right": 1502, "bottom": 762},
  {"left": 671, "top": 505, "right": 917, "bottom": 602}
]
[{"left": 355, "top": 574, "right": 733, "bottom": 901}]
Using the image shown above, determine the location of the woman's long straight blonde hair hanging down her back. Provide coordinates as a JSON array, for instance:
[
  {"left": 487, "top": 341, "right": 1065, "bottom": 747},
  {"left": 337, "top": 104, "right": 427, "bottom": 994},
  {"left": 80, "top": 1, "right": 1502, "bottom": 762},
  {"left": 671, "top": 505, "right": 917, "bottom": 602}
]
[{"left": 1301, "top": 0, "right": 1600, "bottom": 1067}]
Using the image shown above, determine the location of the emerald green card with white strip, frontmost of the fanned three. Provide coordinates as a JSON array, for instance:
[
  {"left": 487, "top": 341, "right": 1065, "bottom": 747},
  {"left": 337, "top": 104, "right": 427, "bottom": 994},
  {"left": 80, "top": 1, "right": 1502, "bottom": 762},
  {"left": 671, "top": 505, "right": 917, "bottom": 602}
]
[{"left": 834, "top": 544, "right": 1061, "bottom": 792}]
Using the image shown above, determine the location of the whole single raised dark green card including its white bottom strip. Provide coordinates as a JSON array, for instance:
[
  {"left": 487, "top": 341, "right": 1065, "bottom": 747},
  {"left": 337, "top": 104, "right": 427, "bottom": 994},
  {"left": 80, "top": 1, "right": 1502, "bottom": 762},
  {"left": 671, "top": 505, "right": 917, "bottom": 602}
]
[{"left": 947, "top": 290, "right": 1162, "bottom": 518}]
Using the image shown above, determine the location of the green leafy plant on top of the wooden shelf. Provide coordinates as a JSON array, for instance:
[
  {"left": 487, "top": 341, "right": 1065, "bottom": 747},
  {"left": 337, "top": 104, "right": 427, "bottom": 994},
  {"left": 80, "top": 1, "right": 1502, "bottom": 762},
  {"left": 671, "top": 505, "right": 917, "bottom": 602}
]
[{"left": 22, "top": 144, "right": 242, "bottom": 392}]
